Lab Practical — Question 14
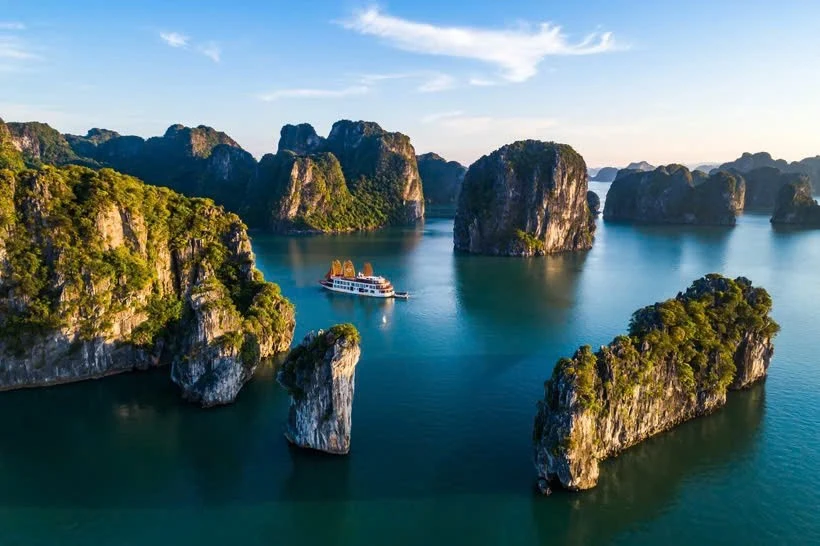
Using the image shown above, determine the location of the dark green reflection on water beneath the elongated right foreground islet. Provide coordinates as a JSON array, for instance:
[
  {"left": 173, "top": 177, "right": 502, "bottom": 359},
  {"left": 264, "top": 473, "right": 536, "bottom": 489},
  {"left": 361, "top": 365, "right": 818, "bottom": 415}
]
[{"left": 532, "top": 385, "right": 766, "bottom": 544}]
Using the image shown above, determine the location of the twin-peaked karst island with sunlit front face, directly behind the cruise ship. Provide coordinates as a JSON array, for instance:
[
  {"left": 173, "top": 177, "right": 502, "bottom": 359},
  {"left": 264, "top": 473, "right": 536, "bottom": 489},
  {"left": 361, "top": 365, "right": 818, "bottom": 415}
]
[{"left": 253, "top": 120, "right": 424, "bottom": 233}]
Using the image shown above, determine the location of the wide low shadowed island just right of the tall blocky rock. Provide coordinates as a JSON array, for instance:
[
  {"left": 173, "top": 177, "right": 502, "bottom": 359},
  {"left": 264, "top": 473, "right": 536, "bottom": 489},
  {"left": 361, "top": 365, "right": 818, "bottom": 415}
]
[{"left": 604, "top": 165, "right": 745, "bottom": 225}]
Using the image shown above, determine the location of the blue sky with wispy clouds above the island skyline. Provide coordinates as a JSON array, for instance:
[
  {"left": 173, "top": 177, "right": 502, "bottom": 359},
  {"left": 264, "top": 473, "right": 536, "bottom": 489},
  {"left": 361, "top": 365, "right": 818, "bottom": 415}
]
[{"left": 0, "top": 0, "right": 820, "bottom": 166}]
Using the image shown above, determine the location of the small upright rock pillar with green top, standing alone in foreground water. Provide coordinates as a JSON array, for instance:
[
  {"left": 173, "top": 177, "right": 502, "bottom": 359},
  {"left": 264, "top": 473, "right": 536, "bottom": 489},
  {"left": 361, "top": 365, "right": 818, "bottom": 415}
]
[{"left": 277, "top": 324, "right": 361, "bottom": 455}]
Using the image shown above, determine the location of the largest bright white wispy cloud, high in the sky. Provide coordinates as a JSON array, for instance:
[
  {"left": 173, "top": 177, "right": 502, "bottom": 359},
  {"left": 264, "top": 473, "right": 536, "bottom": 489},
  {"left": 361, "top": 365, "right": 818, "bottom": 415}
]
[{"left": 342, "top": 7, "right": 615, "bottom": 82}]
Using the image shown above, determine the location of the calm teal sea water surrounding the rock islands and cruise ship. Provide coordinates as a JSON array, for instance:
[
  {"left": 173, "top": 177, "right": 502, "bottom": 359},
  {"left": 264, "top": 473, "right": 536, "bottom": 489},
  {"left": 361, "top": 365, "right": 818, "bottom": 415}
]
[{"left": 0, "top": 184, "right": 820, "bottom": 546}]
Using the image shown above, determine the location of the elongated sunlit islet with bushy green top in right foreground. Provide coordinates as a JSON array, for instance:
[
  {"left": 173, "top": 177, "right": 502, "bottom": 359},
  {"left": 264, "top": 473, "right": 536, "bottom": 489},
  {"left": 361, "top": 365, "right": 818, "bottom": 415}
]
[{"left": 533, "top": 275, "right": 778, "bottom": 490}]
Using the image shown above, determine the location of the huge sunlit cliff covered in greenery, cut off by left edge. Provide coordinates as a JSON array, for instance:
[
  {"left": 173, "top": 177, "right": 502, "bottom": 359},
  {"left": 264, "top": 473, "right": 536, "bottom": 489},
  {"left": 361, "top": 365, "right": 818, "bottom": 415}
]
[{"left": 0, "top": 118, "right": 294, "bottom": 406}]
